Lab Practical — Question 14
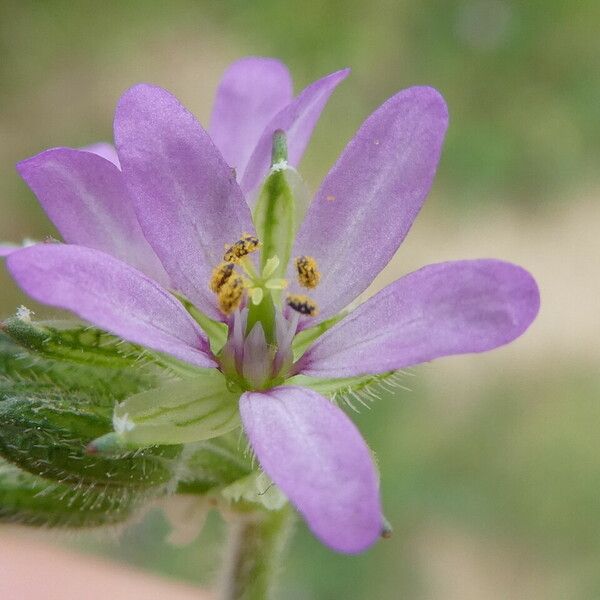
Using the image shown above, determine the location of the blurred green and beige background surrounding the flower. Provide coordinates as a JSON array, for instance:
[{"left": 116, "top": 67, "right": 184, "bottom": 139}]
[{"left": 0, "top": 0, "right": 600, "bottom": 600}]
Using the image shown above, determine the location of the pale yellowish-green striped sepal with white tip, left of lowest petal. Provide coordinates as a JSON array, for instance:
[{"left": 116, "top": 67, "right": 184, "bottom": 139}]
[{"left": 104, "top": 369, "right": 240, "bottom": 448}]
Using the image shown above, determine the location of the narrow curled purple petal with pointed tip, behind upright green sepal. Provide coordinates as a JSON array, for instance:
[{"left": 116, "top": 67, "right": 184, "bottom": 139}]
[{"left": 241, "top": 69, "right": 350, "bottom": 194}]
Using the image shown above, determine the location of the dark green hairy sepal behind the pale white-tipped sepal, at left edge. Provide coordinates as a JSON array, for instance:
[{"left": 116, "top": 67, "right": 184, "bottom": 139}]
[{"left": 0, "top": 384, "right": 181, "bottom": 489}]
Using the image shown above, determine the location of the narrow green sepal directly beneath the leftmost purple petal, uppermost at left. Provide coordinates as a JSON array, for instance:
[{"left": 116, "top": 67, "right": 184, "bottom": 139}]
[{"left": 1, "top": 317, "right": 151, "bottom": 370}]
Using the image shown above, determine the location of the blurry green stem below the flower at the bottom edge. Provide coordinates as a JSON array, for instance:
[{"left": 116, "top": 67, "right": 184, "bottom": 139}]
[{"left": 219, "top": 506, "right": 294, "bottom": 600}]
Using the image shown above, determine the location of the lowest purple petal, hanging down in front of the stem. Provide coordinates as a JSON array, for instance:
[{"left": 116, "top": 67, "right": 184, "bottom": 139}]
[{"left": 240, "top": 386, "right": 382, "bottom": 553}]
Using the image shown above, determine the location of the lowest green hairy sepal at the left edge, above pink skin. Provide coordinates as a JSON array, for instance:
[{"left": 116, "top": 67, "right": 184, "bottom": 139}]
[{"left": 0, "top": 462, "right": 142, "bottom": 528}]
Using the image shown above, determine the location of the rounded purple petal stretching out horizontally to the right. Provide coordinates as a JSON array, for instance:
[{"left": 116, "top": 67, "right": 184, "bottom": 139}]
[{"left": 299, "top": 260, "right": 540, "bottom": 377}]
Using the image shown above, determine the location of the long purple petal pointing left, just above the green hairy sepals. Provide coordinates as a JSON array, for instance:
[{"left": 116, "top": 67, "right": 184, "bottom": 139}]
[{"left": 7, "top": 244, "right": 215, "bottom": 367}]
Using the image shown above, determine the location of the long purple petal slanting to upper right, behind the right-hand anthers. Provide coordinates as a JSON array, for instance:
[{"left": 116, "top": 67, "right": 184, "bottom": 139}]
[{"left": 294, "top": 88, "right": 448, "bottom": 320}]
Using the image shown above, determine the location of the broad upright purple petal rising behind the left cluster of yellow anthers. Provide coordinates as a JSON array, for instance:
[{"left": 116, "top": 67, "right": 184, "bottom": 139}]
[{"left": 115, "top": 84, "right": 253, "bottom": 319}]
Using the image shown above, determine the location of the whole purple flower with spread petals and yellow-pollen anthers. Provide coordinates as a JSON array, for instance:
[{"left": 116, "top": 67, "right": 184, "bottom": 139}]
[{"left": 8, "top": 58, "right": 539, "bottom": 552}]
